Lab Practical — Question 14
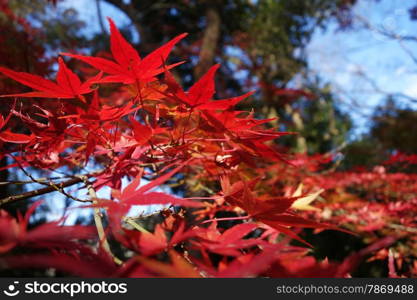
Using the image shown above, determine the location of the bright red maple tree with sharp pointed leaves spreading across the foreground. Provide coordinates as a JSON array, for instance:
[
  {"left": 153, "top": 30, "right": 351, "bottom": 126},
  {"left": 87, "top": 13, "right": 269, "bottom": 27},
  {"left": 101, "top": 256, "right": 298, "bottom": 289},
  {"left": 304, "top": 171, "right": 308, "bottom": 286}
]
[{"left": 0, "top": 15, "right": 416, "bottom": 277}]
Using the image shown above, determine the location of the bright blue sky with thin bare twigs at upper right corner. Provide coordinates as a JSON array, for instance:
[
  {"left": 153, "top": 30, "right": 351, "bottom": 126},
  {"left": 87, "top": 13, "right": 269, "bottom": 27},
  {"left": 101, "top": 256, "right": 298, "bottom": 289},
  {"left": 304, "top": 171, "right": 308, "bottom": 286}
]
[{"left": 308, "top": 0, "right": 417, "bottom": 134}]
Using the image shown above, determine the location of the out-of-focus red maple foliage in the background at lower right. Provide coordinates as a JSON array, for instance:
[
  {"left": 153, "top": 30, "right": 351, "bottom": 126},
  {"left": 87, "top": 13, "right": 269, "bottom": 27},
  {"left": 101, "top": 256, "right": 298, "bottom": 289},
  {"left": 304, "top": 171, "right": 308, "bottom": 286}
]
[{"left": 264, "top": 153, "right": 417, "bottom": 277}]
